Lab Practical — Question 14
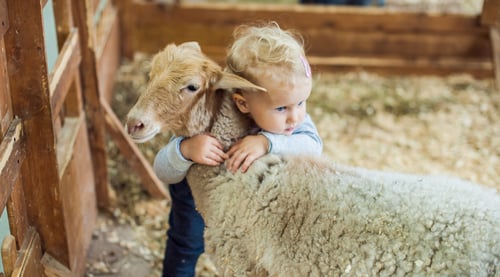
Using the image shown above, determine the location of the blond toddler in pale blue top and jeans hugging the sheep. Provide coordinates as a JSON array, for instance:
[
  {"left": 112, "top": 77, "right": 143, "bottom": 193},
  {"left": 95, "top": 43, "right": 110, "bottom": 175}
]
[{"left": 154, "top": 23, "right": 323, "bottom": 277}]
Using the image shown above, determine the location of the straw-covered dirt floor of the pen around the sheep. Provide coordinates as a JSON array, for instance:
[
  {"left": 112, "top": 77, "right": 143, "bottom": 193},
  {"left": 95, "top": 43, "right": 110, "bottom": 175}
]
[{"left": 86, "top": 0, "right": 494, "bottom": 277}]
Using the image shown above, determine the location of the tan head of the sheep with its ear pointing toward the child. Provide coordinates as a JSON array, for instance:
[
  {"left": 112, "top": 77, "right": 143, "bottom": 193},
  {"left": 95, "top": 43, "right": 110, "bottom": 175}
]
[{"left": 125, "top": 42, "right": 263, "bottom": 143}]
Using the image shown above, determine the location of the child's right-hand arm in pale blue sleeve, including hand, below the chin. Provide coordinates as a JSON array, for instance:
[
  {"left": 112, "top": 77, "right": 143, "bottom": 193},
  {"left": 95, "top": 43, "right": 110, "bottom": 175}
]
[{"left": 226, "top": 115, "right": 323, "bottom": 172}]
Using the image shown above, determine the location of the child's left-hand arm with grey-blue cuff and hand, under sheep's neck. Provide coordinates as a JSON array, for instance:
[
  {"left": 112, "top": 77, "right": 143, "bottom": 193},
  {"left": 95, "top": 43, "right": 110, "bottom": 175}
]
[{"left": 153, "top": 134, "right": 227, "bottom": 184}]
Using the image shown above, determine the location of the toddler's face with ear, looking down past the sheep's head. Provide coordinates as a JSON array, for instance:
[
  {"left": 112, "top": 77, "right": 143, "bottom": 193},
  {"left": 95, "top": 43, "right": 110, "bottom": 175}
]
[{"left": 235, "top": 76, "right": 312, "bottom": 135}]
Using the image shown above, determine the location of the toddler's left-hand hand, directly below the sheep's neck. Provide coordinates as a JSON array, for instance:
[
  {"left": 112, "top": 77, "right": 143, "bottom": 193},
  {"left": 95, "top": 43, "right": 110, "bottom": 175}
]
[{"left": 180, "top": 134, "right": 228, "bottom": 166}]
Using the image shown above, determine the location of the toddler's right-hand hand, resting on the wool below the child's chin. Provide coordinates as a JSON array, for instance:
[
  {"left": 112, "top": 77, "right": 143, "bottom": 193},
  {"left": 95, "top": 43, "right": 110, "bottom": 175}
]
[{"left": 226, "top": 135, "right": 269, "bottom": 173}]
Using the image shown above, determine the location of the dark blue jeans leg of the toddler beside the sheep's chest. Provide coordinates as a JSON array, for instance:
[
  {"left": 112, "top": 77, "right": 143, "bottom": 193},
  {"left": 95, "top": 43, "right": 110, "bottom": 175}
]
[{"left": 162, "top": 178, "right": 205, "bottom": 277}]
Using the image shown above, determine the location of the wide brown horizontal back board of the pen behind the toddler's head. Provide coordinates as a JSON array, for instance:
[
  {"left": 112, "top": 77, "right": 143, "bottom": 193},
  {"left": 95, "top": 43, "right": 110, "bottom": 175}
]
[{"left": 117, "top": 0, "right": 497, "bottom": 77}]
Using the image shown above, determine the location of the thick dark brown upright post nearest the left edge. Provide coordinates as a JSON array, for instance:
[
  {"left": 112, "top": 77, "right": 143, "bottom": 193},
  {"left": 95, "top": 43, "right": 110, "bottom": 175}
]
[{"left": 5, "top": 0, "right": 68, "bottom": 263}]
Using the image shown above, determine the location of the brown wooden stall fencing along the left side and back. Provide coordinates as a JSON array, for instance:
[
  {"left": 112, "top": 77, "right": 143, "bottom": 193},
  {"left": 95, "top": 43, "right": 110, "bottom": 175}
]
[{"left": 0, "top": 0, "right": 500, "bottom": 276}]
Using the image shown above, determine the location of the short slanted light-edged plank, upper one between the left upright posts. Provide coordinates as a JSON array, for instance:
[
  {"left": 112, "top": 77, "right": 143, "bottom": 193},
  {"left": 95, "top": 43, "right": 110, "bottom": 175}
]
[{"left": 49, "top": 29, "right": 81, "bottom": 118}]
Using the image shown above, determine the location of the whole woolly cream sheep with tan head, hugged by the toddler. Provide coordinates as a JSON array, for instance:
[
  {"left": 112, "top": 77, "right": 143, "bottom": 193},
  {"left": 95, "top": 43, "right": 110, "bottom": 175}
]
[{"left": 126, "top": 42, "right": 500, "bottom": 276}]
